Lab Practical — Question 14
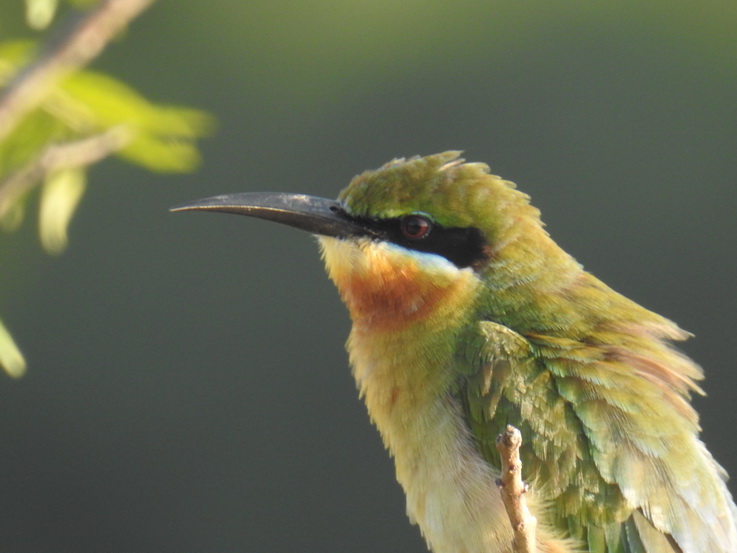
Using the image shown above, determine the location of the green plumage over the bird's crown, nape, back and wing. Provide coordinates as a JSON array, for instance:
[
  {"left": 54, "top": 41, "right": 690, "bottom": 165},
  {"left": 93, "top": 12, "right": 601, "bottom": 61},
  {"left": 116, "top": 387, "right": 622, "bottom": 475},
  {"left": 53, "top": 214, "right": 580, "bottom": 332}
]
[{"left": 340, "top": 152, "right": 737, "bottom": 553}]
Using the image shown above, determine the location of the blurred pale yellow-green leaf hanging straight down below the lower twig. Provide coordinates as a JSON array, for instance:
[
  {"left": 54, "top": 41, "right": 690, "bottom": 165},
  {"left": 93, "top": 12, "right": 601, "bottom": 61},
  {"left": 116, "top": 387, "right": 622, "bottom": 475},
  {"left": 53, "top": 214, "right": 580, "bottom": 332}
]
[{"left": 38, "top": 169, "right": 86, "bottom": 253}]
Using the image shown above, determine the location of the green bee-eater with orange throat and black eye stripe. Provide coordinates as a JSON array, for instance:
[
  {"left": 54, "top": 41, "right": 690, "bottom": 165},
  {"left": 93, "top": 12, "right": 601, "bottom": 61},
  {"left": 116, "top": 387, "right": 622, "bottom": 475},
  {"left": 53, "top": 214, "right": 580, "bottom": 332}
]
[{"left": 172, "top": 151, "right": 737, "bottom": 553}]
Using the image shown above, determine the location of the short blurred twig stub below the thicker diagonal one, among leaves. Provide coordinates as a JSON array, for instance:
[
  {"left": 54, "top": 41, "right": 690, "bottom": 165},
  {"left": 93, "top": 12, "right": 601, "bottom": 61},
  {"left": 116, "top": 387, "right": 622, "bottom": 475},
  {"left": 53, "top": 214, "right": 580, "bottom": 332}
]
[{"left": 0, "top": 127, "right": 129, "bottom": 218}]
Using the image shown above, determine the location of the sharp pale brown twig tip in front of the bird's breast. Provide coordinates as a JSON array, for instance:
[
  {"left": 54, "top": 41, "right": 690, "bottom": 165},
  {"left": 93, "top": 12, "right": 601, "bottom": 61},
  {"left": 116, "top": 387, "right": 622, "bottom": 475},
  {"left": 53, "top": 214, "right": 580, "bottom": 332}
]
[{"left": 496, "top": 426, "right": 537, "bottom": 553}]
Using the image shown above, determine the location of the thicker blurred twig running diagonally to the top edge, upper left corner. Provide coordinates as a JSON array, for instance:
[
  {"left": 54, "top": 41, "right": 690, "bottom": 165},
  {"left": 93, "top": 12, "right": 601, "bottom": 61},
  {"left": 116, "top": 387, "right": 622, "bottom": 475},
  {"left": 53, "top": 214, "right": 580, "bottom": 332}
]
[{"left": 0, "top": 0, "right": 155, "bottom": 142}]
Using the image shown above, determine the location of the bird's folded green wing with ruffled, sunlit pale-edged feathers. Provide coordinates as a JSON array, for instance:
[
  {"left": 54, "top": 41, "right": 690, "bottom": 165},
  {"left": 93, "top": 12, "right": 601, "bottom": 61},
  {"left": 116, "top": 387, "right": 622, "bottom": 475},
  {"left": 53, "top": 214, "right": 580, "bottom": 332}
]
[{"left": 462, "top": 321, "right": 737, "bottom": 553}]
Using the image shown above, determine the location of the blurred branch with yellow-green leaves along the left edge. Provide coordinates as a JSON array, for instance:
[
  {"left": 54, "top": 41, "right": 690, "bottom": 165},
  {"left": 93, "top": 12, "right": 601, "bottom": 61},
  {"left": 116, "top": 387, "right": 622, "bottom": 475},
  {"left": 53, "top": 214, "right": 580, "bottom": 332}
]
[{"left": 0, "top": 0, "right": 212, "bottom": 376}]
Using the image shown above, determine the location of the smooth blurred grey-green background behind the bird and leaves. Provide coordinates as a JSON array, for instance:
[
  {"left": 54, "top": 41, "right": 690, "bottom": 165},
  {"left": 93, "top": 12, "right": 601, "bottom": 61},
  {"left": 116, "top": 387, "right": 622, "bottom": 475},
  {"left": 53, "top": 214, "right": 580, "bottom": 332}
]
[{"left": 0, "top": 0, "right": 737, "bottom": 553}]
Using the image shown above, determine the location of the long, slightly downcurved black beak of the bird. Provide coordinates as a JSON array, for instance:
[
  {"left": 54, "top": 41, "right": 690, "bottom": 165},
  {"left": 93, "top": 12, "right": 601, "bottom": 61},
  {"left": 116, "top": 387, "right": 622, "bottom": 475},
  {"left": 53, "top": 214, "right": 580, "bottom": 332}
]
[{"left": 171, "top": 192, "right": 372, "bottom": 238}]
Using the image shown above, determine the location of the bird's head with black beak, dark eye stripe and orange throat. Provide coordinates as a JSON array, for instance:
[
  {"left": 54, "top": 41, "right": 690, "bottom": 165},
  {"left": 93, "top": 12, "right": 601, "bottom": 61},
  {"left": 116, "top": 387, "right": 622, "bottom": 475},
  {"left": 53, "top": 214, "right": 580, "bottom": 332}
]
[{"left": 173, "top": 151, "right": 568, "bottom": 329}]
